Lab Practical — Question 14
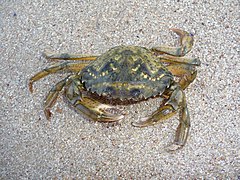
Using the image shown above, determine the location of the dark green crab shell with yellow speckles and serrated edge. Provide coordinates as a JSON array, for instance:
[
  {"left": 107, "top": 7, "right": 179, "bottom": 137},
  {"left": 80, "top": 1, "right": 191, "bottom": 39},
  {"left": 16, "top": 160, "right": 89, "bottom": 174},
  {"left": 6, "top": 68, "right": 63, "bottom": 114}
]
[{"left": 80, "top": 46, "right": 173, "bottom": 100}]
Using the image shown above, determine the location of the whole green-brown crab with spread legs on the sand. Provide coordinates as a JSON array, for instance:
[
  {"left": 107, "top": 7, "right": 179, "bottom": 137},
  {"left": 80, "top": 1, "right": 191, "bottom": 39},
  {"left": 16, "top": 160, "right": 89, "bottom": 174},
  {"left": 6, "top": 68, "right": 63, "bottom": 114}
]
[{"left": 29, "top": 29, "right": 200, "bottom": 151}]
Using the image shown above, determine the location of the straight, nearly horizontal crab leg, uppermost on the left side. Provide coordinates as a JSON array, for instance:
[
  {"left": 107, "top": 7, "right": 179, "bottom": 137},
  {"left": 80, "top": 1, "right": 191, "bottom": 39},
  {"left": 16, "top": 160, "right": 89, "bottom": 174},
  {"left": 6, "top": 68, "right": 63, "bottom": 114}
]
[{"left": 43, "top": 52, "right": 99, "bottom": 61}]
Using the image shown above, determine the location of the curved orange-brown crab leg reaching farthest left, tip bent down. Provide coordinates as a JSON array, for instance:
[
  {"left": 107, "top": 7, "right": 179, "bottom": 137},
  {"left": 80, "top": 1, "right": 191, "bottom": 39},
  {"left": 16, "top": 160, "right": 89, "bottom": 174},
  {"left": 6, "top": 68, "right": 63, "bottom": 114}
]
[{"left": 28, "top": 62, "right": 88, "bottom": 92}]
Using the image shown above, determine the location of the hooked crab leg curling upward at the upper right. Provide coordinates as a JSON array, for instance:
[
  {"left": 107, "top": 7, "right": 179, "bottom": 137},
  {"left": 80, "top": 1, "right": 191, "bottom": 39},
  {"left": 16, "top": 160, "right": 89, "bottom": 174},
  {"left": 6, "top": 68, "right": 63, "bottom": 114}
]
[{"left": 152, "top": 28, "right": 193, "bottom": 56}]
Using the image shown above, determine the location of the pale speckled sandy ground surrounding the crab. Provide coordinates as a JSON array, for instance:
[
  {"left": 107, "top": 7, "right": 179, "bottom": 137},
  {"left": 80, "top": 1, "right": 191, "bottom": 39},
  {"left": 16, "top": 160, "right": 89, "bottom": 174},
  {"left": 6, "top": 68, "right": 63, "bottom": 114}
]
[{"left": 0, "top": 0, "right": 240, "bottom": 179}]
